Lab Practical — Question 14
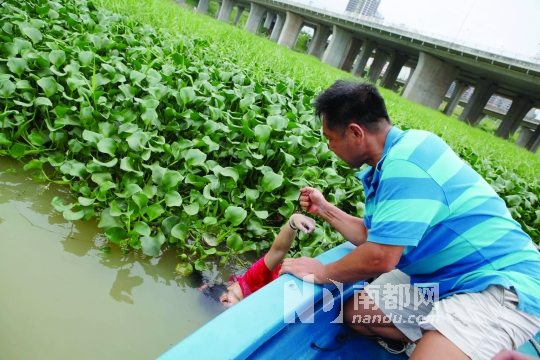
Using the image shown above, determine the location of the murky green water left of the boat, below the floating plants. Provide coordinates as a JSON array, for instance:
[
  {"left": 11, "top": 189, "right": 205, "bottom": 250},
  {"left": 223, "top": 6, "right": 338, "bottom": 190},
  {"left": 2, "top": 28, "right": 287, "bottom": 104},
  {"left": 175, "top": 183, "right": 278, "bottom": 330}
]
[{"left": 0, "top": 158, "right": 229, "bottom": 360}]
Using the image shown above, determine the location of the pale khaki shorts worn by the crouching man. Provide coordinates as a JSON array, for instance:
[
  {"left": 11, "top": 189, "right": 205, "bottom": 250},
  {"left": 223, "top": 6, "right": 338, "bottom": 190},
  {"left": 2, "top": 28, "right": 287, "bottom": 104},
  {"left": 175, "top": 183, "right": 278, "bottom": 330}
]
[{"left": 364, "top": 270, "right": 540, "bottom": 359}]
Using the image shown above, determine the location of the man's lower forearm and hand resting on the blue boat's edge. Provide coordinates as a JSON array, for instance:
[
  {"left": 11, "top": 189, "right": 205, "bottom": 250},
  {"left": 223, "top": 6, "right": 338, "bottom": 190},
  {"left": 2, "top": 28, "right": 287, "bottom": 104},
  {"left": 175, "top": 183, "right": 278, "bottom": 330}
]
[{"left": 279, "top": 242, "right": 404, "bottom": 284}]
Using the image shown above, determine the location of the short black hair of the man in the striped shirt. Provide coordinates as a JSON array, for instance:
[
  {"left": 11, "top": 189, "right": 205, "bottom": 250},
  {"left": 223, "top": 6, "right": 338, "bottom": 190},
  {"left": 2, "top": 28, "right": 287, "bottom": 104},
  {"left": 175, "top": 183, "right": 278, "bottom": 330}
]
[{"left": 314, "top": 80, "right": 392, "bottom": 134}]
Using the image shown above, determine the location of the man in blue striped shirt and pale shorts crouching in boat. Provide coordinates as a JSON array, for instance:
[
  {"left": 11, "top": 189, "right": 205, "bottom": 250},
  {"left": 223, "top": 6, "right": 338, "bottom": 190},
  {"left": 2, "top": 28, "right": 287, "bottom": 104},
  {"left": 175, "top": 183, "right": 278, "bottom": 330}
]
[{"left": 280, "top": 81, "right": 540, "bottom": 359}]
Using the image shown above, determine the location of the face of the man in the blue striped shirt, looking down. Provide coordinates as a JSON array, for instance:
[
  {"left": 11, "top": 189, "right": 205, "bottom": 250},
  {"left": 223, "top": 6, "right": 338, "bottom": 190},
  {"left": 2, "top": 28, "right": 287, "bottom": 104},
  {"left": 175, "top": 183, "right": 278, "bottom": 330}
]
[{"left": 323, "top": 114, "right": 365, "bottom": 169}]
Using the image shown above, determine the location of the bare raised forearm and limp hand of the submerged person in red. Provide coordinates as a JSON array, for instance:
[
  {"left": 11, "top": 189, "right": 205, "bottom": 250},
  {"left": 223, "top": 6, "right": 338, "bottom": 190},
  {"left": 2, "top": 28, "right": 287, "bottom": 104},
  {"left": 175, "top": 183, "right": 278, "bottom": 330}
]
[{"left": 264, "top": 214, "right": 315, "bottom": 271}]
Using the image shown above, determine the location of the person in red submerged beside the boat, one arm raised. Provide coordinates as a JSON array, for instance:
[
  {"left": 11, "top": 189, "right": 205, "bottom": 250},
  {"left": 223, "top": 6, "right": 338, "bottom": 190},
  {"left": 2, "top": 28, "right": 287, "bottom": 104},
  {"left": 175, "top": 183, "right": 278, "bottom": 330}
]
[{"left": 200, "top": 214, "right": 315, "bottom": 308}]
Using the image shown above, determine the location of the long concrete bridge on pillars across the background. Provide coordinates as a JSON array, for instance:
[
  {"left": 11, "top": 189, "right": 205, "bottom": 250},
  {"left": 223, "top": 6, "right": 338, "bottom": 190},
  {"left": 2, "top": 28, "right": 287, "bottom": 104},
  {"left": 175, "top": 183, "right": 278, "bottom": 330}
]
[{"left": 184, "top": 0, "right": 540, "bottom": 152}]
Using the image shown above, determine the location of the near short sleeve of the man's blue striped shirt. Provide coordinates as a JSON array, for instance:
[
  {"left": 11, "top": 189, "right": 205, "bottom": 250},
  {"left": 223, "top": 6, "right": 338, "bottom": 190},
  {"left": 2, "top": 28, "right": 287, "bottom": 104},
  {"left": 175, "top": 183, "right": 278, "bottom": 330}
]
[{"left": 366, "top": 159, "right": 450, "bottom": 246}]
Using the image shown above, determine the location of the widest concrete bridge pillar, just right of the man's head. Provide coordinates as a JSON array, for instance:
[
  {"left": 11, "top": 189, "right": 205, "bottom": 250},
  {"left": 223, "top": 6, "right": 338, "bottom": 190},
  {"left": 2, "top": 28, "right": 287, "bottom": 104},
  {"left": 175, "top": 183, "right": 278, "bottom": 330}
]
[{"left": 403, "top": 52, "right": 459, "bottom": 110}]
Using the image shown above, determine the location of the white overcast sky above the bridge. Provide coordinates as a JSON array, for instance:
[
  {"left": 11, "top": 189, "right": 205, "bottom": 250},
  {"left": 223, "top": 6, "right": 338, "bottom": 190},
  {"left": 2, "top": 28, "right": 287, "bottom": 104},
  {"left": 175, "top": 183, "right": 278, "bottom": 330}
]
[{"left": 300, "top": 0, "right": 540, "bottom": 58}]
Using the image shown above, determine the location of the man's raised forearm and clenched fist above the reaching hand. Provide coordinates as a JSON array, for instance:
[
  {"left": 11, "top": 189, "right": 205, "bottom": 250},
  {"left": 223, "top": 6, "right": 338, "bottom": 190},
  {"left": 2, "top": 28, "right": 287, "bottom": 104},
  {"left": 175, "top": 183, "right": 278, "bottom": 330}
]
[{"left": 300, "top": 187, "right": 368, "bottom": 246}]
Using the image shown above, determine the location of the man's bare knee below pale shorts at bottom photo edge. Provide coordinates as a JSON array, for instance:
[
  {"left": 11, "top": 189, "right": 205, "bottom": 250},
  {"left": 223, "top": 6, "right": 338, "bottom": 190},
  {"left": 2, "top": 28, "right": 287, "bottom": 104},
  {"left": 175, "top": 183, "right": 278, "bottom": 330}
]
[{"left": 411, "top": 330, "right": 469, "bottom": 360}]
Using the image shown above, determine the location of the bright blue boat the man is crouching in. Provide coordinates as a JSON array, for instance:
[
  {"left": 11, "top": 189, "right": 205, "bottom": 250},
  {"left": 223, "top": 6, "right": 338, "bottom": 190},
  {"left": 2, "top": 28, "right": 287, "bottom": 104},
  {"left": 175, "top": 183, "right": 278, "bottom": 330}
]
[{"left": 158, "top": 243, "right": 540, "bottom": 360}]
